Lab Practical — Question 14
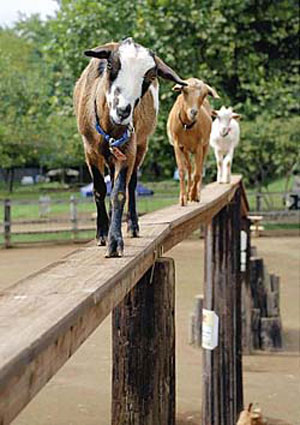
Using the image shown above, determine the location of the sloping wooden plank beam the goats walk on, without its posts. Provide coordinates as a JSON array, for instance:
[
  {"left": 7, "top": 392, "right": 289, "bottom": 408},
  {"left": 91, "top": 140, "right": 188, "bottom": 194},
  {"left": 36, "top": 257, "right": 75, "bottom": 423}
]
[{"left": 0, "top": 176, "right": 248, "bottom": 425}]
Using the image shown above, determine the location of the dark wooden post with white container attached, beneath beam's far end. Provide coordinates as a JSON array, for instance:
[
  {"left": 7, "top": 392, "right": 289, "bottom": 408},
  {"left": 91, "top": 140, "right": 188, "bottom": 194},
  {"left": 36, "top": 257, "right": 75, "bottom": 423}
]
[{"left": 202, "top": 191, "right": 243, "bottom": 425}]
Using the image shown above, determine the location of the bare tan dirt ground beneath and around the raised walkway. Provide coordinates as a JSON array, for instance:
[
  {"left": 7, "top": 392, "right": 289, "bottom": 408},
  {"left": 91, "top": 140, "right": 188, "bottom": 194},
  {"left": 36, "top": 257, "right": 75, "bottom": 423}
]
[{"left": 0, "top": 238, "right": 300, "bottom": 425}]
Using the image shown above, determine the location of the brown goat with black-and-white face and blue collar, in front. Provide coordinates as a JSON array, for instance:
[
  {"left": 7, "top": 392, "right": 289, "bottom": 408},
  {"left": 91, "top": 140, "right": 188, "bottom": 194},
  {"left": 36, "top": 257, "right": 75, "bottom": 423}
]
[{"left": 74, "top": 38, "right": 186, "bottom": 257}]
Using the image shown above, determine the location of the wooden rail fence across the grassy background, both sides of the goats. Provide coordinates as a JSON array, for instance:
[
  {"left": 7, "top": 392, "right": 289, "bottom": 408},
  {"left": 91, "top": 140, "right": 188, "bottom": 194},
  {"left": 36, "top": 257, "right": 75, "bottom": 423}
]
[{"left": 0, "top": 192, "right": 300, "bottom": 248}]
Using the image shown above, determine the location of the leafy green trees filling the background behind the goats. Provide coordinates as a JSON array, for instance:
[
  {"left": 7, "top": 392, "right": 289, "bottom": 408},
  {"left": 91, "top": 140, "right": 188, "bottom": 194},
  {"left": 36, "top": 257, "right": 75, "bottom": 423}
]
[{"left": 0, "top": 0, "right": 300, "bottom": 186}]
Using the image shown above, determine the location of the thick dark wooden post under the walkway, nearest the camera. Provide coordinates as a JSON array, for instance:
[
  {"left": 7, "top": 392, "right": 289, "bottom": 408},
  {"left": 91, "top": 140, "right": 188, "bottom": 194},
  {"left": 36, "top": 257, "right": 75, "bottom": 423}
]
[{"left": 112, "top": 258, "right": 175, "bottom": 425}]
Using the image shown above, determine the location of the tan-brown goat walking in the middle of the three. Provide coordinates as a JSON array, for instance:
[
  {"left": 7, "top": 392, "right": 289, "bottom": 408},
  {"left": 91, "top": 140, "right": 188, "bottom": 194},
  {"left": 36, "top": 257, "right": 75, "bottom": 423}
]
[{"left": 167, "top": 78, "right": 219, "bottom": 206}]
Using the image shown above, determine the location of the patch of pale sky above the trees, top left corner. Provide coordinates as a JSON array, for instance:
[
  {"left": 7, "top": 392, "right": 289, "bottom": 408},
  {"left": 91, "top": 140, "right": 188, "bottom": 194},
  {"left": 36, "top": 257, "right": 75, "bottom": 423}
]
[{"left": 0, "top": 0, "right": 58, "bottom": 26}]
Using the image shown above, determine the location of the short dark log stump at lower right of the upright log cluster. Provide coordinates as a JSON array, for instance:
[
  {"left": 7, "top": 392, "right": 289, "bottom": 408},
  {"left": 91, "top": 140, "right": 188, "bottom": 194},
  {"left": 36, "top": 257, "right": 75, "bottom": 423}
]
[{"left": 260, "top": 317, "right": 282, "bottom": 351}]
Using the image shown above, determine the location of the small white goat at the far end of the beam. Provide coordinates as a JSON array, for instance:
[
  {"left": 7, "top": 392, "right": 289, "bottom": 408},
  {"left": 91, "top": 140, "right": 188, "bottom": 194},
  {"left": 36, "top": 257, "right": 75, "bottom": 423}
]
[{"left": 209, "top": 106, "right": 240, "bottom": 183}]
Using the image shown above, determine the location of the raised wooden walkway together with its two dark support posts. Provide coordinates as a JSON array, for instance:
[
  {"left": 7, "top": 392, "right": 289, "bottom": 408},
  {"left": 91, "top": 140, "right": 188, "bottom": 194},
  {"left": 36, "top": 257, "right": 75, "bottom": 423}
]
[{"left": 0, "top": 176, "right": 248, "bottom": 425}]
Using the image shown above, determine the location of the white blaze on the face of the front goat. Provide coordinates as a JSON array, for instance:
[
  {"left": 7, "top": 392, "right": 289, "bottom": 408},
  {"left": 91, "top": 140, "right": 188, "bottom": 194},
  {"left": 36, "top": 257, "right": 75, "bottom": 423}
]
[{"left": 107, "top": 42, "right": 155, "bottom": 125}]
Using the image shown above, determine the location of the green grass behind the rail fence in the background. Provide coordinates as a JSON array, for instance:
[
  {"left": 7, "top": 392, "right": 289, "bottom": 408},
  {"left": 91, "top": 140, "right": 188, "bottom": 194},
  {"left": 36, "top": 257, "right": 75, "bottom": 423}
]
[{"left": 0, "top": 179, "right": 298, "bottom": 244}]
